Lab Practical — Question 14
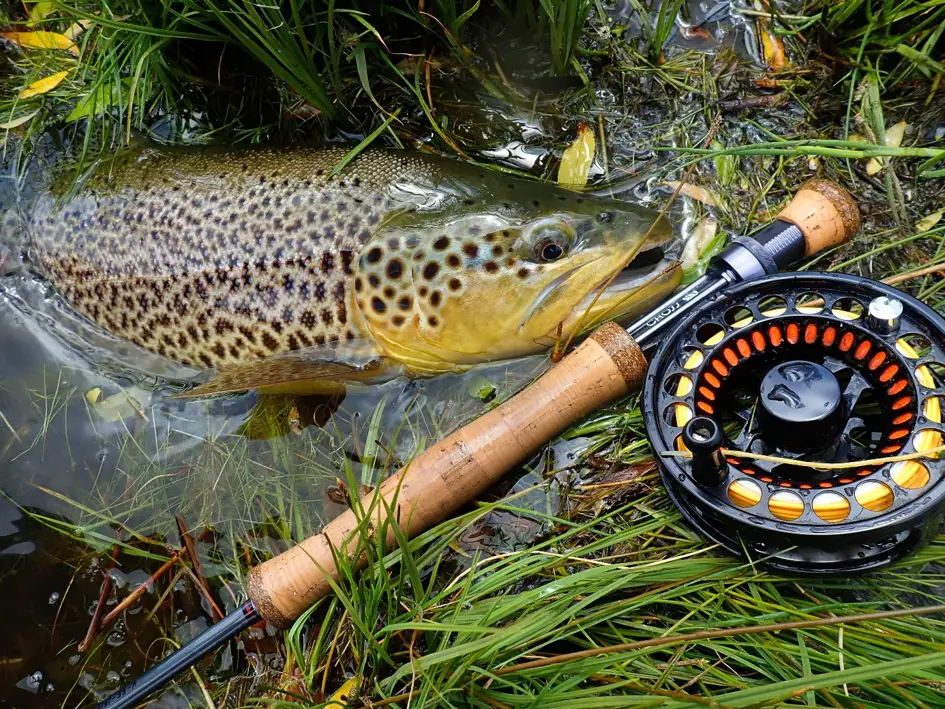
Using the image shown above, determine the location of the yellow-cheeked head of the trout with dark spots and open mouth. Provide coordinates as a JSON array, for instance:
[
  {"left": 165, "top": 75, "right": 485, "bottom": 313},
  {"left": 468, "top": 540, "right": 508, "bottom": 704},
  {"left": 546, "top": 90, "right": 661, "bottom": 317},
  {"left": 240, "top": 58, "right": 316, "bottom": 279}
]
[{"left": 355, "top": 183, "right": 679, "bottom": 374}]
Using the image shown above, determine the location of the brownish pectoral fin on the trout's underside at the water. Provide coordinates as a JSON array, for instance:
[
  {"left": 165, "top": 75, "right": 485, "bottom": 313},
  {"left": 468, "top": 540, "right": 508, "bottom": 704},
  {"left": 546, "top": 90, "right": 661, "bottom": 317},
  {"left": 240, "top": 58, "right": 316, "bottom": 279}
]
[{"left": 175, "top": 350, "right": 403, "bottom": 398}]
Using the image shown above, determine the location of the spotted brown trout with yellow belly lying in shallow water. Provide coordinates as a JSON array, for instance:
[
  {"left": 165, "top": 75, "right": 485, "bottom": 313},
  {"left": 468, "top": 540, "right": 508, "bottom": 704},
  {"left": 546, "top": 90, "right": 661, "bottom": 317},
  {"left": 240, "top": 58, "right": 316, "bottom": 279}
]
[{"left": 27, "top": 147, "right": 679, "bottom": 394}]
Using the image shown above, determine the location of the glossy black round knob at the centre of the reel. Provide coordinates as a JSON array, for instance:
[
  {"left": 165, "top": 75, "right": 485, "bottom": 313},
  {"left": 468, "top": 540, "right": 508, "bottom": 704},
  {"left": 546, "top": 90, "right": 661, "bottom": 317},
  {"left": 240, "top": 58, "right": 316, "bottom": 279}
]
[{"left": 757, "top": 360, "right": 845, "bottom": 453}]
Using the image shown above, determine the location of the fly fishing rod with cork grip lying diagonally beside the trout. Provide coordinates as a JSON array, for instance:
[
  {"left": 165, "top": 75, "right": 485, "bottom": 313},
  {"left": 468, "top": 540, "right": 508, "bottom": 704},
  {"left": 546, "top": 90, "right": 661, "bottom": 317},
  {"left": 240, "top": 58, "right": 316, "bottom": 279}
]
[{"left": 99, "top": 180, "right": 860, "bottom": 709}]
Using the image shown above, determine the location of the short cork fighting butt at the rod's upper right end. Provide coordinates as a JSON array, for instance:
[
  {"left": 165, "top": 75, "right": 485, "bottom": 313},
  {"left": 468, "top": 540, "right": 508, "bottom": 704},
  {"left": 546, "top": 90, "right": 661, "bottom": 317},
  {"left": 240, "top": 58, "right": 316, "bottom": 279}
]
[{"left": 778, "top": 179, "right": 860, "bottom": 256}]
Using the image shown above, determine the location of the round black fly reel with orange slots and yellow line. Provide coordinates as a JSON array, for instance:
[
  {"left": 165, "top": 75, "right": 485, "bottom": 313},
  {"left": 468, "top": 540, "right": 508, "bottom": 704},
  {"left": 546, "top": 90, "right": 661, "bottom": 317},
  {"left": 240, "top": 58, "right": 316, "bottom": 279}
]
[{"left": 644, "top": 273, "right": 945, "bottom": 573}]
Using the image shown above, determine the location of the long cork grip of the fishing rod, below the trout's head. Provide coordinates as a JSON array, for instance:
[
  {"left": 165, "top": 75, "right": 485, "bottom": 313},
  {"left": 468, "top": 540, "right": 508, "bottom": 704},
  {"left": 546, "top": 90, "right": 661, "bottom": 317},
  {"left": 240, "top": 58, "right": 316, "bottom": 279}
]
[{"left": 249, "top": 323, "right": 646, "bottom": 627}]
